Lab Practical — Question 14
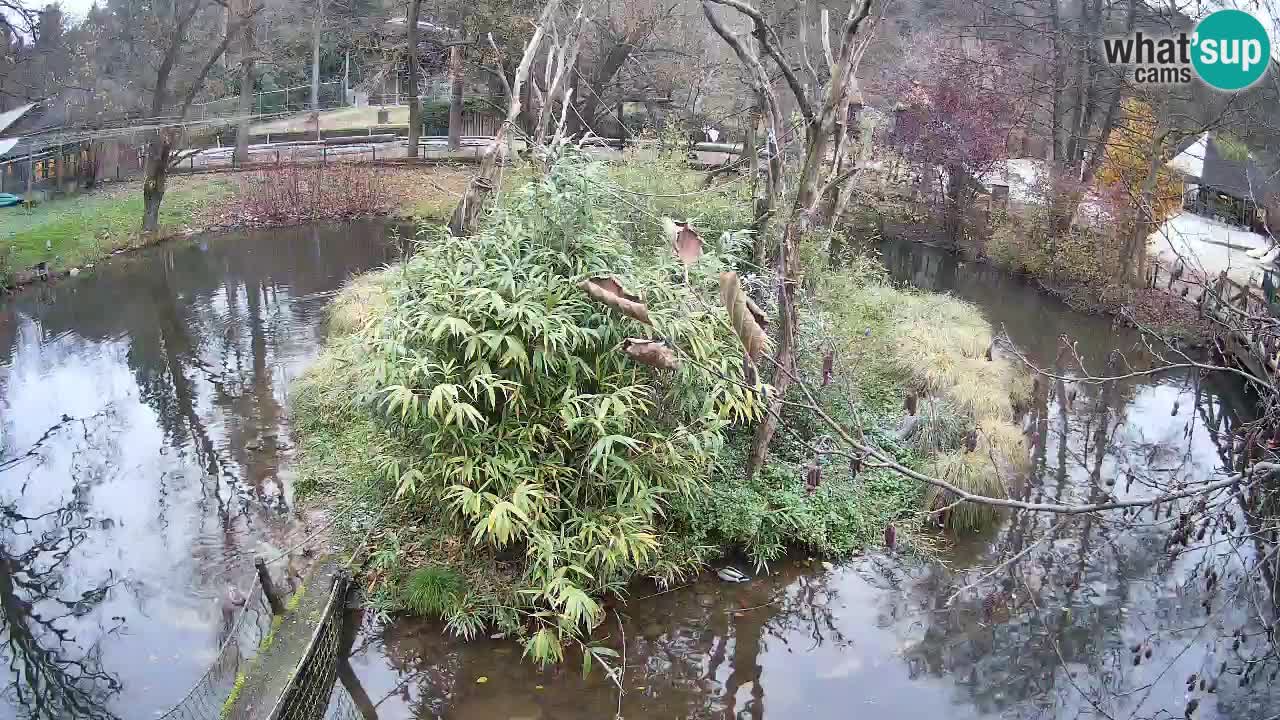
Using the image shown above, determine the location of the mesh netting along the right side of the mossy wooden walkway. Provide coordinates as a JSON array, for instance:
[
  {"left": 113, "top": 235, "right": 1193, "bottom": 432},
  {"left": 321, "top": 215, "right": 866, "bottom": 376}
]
[{"left": 271, "top": 574, "right": 347, "bottom": 720}]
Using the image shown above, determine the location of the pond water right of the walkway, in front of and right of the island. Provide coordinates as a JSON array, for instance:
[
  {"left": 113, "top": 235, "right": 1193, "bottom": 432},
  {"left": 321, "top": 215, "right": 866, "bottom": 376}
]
[{"left": 352, "top": 238, "right": 1280, "bottom": 720}]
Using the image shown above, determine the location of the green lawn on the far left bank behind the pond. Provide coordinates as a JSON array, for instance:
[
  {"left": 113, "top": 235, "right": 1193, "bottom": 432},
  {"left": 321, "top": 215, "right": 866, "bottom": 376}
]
[{"left": 0, "top": 176, "right": 233, "bottom": 279}]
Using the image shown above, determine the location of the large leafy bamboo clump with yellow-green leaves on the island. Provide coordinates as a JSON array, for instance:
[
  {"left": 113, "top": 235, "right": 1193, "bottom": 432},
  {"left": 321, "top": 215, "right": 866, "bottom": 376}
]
[{"left": 296, "top": 152, "right": 758, "bottom": 652}]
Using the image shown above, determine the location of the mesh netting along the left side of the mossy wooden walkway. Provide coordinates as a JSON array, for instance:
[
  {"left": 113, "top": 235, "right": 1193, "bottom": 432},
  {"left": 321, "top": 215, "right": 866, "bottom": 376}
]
[{"left": 157, "top": 574, "right": 271, "bottom": 720}]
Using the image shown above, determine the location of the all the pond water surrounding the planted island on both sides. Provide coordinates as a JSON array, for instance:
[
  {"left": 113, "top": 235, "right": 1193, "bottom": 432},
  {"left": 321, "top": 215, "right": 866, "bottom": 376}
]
[{"left": 0, "top": 224, "right": 1280, "bottom": 720}]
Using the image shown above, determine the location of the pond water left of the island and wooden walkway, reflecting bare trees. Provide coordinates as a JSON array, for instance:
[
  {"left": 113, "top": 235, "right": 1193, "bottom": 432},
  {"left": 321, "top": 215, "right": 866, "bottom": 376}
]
[{"left": 0, "top": 225, "right": 397, "bottom": 719}]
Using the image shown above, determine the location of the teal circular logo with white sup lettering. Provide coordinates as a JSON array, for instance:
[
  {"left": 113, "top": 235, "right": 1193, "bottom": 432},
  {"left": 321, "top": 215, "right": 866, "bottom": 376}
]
[{"left": 1192, "top": 10, "right": 1271, "bottom": 90}]
